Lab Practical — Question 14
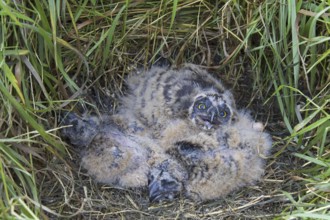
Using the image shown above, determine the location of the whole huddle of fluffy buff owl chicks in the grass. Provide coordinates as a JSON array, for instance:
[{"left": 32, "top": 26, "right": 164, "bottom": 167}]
[{"left": 62, "top": 64, "right": 271, "bottom": 202}]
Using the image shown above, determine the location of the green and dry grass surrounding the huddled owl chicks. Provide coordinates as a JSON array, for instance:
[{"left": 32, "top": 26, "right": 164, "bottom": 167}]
[{"left": 0, "top": 0, "right": 330, "bottom": 219}]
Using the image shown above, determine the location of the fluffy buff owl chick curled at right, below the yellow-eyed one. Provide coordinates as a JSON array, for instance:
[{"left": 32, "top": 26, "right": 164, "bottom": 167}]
[{"left": 149, "top": 112, "right": 272, "bottom": 201}]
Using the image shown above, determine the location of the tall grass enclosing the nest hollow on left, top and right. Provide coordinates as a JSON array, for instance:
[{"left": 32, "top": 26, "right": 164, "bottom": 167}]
[{"left": 0, "top": 0, "right": 330, "bottom": 219}]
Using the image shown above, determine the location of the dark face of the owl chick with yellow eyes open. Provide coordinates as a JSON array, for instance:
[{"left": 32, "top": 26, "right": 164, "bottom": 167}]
[{"left": 189, "top": 94, "right": 233, "bottom": 130}]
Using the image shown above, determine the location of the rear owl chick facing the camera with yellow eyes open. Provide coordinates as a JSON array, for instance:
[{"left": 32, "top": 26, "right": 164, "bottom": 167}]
[{"left": 119, "top": 64, "right": 235, "bottom": 134}]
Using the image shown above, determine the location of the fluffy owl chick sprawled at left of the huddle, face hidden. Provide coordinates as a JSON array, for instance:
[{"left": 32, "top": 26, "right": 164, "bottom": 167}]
[{"left": 61, "top": 113, "right": 187, "bottom": 192}]
